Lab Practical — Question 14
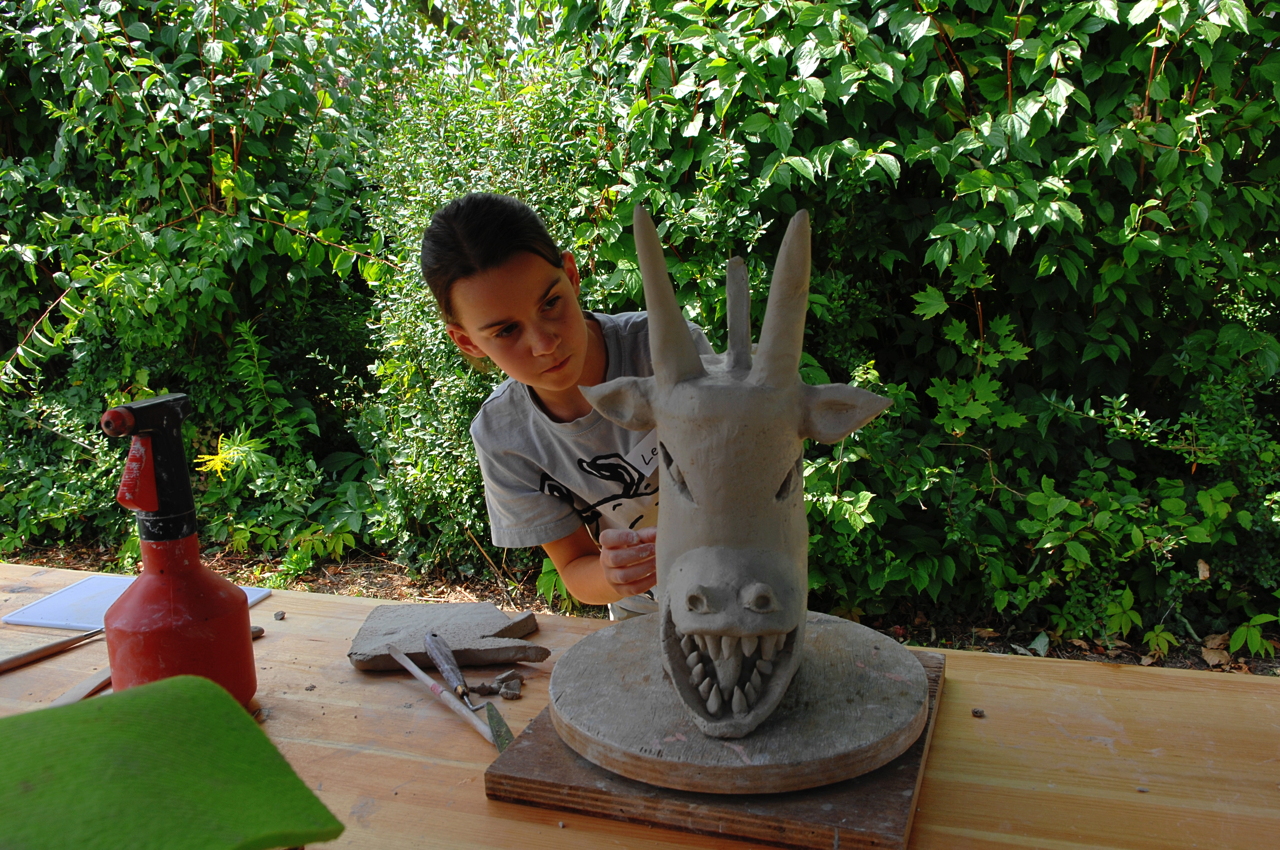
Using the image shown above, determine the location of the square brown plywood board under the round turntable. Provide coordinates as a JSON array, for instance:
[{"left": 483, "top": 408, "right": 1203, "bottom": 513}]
[{"left": 484, "top": 652, "right": 946, "bottom": 850}]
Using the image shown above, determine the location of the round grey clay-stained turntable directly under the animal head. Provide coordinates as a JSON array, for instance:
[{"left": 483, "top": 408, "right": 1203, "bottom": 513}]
[{"left": 550, "top": 612, "right": 929, "bottom": 794}]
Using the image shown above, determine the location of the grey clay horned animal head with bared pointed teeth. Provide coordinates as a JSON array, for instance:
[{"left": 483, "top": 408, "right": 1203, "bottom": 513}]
[{"left": 582, "top": 207, "right": 890, "bottom": 737}]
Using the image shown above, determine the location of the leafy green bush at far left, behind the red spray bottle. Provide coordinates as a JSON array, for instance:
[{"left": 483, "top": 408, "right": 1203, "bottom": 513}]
[{"left": 0, "top": 0, "right": 401, "bottom": 563}]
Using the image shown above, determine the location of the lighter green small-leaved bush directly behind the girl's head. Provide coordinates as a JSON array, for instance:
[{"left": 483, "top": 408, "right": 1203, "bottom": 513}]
[{"left": 362, "top": 33, "right": 624, "bottom": 572}]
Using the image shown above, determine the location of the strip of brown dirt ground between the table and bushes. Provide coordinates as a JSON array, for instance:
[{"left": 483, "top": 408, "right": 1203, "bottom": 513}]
[{"left": 4, "top": 545, "right": 1280, "bottom": 676}]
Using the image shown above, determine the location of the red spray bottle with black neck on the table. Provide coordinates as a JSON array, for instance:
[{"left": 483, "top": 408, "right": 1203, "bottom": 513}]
[{"left": 102, "top": 393, "right": 257, "bottom": 705}]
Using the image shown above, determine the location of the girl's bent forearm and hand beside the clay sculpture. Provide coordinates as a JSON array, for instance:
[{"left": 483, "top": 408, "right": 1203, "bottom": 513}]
[{"left": 543, "top": 526, "right": 658, "bottom": 605}]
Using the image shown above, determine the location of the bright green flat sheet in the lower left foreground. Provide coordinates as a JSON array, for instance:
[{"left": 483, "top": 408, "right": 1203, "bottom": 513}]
[{"left": 0, "top": 676, "right": 343, "bottom": 850}]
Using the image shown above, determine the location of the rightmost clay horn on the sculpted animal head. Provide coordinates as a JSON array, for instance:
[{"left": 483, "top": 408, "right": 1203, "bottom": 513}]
[{"left": 751, "top": 210, "right": 810, "bottom": 387}]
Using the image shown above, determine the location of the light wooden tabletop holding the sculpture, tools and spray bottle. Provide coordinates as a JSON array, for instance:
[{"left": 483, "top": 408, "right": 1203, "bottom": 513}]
[{"left": 0, "top": 565, "right": 1280, "bottom": 850}]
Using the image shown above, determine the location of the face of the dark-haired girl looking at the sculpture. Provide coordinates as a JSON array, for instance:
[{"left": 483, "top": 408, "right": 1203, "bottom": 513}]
[{"left": 447, "top": 251, "right": 588, "bottom": 394}]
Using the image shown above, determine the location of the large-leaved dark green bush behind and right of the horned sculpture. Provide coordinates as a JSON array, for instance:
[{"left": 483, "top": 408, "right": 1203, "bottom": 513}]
[{"left": 491, "top": 0, "right": 1280, "bottom": 639}]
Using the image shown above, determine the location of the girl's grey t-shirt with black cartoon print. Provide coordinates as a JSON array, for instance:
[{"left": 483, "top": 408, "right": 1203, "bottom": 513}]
[{"left": 471, "top": 312, "right": 712, "bottom": 548}]
